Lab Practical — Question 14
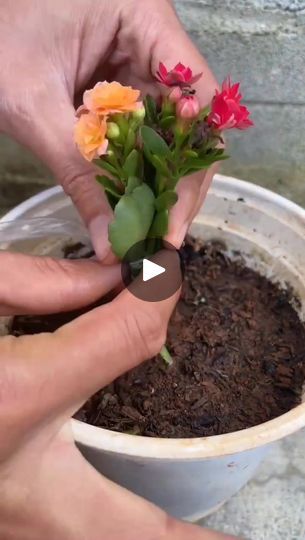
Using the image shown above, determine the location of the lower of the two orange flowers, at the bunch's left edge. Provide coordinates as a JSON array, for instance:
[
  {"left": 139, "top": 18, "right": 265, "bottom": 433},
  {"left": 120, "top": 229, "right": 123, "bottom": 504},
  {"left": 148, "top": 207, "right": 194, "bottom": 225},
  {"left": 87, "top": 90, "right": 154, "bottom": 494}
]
[{"left": 74, "top": 112, "right": 108, "bottom": 161}]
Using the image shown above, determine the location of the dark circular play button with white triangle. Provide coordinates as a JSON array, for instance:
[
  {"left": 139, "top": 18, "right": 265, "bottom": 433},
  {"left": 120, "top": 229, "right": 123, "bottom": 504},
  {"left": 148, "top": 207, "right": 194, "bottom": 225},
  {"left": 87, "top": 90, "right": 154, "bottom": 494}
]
[{"left": 122, "top": 238, "right": 184, "bottom": 302}]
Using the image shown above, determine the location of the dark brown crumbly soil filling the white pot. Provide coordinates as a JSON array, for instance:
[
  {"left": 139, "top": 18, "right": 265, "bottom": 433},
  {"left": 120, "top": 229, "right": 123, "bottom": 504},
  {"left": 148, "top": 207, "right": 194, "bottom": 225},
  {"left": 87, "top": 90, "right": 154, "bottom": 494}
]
[{"left": 11, "top": 239, "right": 305, "bottom": 438}]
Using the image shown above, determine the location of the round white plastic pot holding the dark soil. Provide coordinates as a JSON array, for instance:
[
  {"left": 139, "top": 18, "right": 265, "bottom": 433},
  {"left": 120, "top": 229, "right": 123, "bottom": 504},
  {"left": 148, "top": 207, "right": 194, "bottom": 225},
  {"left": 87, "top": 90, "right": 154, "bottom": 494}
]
[{"left": 0, "top": 175, "right": 305, "bottom": 520}]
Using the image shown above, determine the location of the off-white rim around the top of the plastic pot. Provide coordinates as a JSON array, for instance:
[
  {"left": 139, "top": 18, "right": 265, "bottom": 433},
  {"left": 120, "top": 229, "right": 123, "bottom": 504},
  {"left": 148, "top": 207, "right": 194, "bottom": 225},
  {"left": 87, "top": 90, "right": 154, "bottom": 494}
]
[{"left": 0, "top": 174, "right": 305, "bottom": 460}]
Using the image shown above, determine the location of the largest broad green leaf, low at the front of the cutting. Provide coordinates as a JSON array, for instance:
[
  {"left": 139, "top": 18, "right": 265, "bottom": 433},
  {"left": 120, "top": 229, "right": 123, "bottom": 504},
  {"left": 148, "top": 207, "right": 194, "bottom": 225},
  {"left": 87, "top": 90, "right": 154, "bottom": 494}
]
[{"left": 109, "top": 184, "right": 155, "bottom": 259}]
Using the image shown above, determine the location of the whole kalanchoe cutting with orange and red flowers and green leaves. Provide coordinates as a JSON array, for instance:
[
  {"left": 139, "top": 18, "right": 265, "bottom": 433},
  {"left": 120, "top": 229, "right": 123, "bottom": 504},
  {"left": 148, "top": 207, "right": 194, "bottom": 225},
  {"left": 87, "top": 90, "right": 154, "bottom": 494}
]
[{"left": 75, "top": 63, "right": 253, "bottom": 362}]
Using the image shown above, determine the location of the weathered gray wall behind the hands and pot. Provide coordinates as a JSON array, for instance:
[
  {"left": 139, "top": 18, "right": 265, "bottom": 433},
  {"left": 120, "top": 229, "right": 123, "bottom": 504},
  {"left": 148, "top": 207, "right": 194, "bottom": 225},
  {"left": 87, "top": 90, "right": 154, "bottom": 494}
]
[{"left": 0, "top": 0, "right": 305, "bottom": 212}]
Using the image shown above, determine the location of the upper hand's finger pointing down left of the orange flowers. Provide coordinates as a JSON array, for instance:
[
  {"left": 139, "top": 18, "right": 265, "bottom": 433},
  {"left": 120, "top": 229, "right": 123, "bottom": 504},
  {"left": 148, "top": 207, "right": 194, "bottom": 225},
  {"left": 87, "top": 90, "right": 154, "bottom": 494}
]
[{"left": 4, "top": 81, "right": 112, "bottom": 260}]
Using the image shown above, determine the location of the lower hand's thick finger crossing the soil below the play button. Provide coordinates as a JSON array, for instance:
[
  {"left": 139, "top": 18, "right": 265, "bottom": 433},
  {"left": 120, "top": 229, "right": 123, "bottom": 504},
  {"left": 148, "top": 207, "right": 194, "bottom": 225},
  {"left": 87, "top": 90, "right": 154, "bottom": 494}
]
[{"left": 0, "top": 278, "right": 178, "bottom": 452}]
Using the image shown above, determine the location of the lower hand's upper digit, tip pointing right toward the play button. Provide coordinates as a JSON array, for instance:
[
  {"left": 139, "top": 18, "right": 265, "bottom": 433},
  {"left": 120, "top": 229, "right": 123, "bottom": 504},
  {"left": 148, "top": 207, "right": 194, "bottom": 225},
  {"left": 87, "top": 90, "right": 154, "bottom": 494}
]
[{"left": 0, "top": 253, "right": 121, "bottom": 315}]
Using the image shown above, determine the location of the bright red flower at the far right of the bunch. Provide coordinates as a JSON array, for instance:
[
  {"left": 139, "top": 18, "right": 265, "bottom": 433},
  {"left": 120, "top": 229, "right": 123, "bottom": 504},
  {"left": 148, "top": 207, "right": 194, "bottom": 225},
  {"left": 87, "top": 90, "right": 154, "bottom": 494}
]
[{"left": 208, "top": 77, "right": 254, "bottom": 131}]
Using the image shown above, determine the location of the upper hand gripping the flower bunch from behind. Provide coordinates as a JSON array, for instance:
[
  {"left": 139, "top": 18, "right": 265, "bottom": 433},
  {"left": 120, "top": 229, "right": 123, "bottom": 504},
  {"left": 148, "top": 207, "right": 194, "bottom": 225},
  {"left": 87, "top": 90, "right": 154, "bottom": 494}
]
[{"left": 0, "top": 0, "right": 217, "bottom": 259}]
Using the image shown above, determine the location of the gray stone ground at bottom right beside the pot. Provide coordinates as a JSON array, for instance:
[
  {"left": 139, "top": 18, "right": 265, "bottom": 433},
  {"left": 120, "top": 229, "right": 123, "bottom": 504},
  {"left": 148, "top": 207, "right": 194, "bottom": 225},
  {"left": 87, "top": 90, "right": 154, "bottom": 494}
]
[{"left": 201, "top": 431, "right": 305, "bottom": 540}]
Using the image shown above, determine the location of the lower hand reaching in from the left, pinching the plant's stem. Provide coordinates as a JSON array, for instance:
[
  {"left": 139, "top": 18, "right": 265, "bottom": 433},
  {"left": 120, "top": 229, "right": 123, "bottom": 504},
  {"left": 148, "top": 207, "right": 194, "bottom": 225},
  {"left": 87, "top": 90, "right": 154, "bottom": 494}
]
[{"left": 0, "top": 253, "right": 235, "bottom": 540}]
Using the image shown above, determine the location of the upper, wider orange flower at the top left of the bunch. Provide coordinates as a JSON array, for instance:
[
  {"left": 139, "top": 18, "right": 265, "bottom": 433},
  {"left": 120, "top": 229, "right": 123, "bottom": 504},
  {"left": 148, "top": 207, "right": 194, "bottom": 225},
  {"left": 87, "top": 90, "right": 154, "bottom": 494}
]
[{"left": 84, "top": 81, "right": 143, "bottom": 116}]
